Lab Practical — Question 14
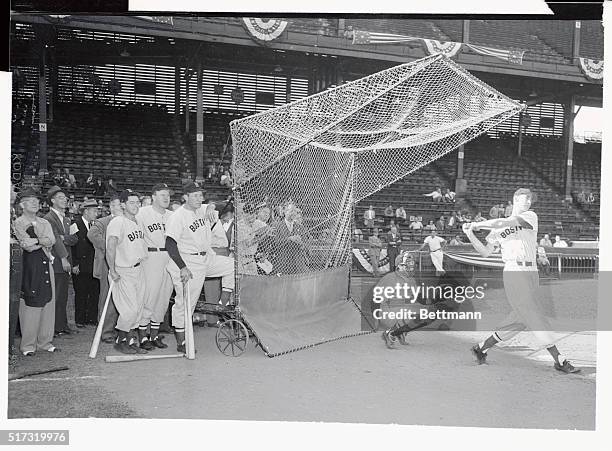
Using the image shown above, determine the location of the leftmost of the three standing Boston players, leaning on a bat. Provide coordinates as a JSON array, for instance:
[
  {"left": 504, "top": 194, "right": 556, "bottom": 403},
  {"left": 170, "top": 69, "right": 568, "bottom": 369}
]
[{"left": 106, "top": 190, "right": 148, "bottom": 354}]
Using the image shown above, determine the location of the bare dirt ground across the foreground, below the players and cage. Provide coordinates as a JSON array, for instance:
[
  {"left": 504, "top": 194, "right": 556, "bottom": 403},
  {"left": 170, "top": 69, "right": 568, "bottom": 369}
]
[{"left": 8, "top": 327, "right": 596, "bottom": 430}]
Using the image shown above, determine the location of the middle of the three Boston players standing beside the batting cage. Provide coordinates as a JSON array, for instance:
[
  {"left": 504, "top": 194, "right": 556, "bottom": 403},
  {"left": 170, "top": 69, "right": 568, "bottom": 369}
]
[{"left": 136, "top": 183, "right": 172, "bottom": 351}]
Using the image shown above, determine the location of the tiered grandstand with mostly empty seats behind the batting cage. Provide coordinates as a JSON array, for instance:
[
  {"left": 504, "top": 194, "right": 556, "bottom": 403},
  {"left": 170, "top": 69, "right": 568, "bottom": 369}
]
[{"left": 11, "top": 14, "right": 603, "bottom": 244}]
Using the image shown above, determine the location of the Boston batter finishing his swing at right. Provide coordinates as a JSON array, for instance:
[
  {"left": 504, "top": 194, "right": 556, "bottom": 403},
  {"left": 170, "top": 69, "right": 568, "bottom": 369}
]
[{"left": 463, "top": 188, "right": 580, "bottom": 373}]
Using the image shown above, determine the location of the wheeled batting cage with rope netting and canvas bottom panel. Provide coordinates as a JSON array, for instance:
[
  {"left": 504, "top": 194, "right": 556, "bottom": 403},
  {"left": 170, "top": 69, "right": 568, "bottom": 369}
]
[{"left": 230, "top": 55, "right": 523, "bottom": 357}]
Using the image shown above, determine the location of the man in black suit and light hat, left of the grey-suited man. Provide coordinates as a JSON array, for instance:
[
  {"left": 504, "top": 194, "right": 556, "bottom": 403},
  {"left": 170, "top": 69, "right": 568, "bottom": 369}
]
[{"left": 72, "top": 199, "right": 100, "bottom": 327}]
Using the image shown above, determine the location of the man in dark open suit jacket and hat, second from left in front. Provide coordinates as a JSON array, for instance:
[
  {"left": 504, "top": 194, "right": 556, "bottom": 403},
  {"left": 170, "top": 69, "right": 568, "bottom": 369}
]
[{"left": 44, "top": 186, "right": 78, "bottom": 335}]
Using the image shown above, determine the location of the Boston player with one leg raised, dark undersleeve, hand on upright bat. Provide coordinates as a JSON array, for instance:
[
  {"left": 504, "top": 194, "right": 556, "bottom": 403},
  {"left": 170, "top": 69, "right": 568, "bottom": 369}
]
[{"left": 166, "top": 182, "right": 234, "bottom": 352}]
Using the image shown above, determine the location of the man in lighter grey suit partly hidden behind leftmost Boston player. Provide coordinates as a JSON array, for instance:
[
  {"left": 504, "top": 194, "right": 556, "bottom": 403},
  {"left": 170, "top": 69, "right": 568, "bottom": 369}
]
[{"left": 87, "top": 195, "right": 123, "bottom": 343}]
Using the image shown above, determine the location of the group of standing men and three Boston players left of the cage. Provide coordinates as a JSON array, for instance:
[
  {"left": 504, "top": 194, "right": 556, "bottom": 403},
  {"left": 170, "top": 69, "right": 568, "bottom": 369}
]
[{"left": 11, "top": 182, "right": 234, "bottom": 355}]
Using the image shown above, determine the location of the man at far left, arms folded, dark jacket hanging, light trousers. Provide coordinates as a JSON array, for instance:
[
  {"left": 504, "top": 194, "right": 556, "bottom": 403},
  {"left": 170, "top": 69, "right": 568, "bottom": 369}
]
[{"left": 13, "top": 189, "right": 59, "bottom": 356}]
